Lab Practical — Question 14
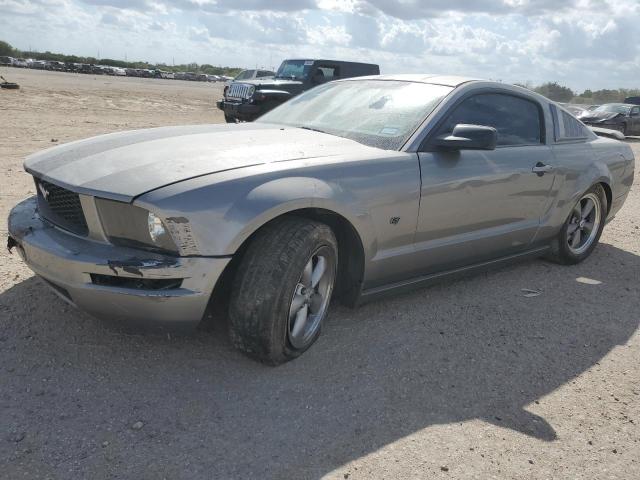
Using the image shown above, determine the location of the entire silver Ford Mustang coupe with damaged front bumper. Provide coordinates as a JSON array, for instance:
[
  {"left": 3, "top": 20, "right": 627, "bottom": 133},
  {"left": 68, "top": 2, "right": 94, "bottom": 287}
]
[{"left": 8, "top": 75, "right": 634, "bottom": 364}]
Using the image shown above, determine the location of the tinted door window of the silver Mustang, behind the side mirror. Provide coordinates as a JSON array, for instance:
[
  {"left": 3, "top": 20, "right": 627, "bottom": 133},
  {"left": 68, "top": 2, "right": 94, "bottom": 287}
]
[{"left": 437, "top": 93, "right": 542, "bottom": 146}]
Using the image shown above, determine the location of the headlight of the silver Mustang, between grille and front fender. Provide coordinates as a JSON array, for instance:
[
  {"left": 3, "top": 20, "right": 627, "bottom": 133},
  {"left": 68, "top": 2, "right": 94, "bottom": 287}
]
[{"left": 96, "top": 198, "right": 178, "bottom": 254}]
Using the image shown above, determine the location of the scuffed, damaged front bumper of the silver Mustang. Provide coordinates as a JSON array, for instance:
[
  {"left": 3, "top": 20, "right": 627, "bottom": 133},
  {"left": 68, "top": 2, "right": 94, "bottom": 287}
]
[{"left": 7, "top": 197, "right": 230, "bottom": 326}]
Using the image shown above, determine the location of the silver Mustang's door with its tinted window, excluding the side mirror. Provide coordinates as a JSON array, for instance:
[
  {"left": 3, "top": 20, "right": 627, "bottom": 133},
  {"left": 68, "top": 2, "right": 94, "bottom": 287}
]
[{"left": 415, "top": 93, "right": 554, "bottom": 273}]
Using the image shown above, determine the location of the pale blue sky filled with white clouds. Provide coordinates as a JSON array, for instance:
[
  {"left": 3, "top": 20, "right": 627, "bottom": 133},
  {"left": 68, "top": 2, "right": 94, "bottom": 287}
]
[{"left": 0, "top": 0, "right": 640, "bottom": 91}]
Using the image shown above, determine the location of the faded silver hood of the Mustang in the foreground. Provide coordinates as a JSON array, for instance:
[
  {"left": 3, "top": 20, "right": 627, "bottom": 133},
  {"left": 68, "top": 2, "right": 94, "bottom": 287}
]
[{"left": 25, "top": 123, "right": 375, "bottom": 202}]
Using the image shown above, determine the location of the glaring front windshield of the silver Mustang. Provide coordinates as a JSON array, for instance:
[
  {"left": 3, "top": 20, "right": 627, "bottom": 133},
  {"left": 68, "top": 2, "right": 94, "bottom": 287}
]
[{"left": 257, "top": 80, "right": 452, "bottom": 150}]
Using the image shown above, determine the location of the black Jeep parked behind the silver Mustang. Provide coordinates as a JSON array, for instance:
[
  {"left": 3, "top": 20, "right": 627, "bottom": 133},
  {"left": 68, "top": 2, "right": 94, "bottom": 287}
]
[{"left": 216, "top": 60, "right": 380, "bottom": 123}]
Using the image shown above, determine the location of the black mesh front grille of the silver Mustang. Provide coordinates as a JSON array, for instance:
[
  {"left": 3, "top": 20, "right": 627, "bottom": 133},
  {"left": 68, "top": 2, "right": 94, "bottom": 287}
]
[{"left": 36, "top": 179, "right": 89, "bottom": 236}]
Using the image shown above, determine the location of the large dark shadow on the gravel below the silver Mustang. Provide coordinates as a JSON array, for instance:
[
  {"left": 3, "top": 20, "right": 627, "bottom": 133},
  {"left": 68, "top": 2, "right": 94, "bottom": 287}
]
[{"left": 0, "top": 244, "right": 640, "bottom": 478}]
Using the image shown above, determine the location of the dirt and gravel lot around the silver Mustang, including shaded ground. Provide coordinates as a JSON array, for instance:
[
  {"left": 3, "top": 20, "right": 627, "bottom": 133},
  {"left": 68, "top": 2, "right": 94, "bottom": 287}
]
[{"left": 0, "top": 68, "right": 640, "bottom": 479}]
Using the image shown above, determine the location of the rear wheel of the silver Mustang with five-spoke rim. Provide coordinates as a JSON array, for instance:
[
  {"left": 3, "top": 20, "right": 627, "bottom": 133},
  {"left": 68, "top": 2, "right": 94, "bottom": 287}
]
[{"left": 551, "top": 184, "right": 607, "bottom": 265}]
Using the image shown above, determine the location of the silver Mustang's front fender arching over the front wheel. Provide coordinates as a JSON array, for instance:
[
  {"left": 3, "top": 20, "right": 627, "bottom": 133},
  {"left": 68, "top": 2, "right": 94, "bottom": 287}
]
[{"left": 135, "top": 167, "right": 373, "bottom": 256}]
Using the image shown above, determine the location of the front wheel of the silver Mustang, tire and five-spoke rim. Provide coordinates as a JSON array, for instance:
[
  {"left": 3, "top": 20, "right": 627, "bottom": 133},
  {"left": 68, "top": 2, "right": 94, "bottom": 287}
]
[{"left": 229, "top": 216, "right": 338, "bottom": 365}]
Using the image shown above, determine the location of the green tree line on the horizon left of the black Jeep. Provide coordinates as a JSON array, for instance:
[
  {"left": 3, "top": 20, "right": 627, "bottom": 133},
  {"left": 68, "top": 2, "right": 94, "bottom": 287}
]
[{"left": 0, "top": 40, "right": 242, "bottom": 77}]
